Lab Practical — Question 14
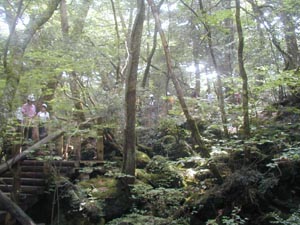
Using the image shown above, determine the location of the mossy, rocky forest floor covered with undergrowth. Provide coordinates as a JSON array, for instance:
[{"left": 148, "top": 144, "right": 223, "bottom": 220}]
[{"left": 25, "top": 100, "right": 300, "bottom": 225}]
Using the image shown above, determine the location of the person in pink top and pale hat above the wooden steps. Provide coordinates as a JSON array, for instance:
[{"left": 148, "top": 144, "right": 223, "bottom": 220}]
[{"left": 21, "top": 94, "right": 36, "bottom": 140}]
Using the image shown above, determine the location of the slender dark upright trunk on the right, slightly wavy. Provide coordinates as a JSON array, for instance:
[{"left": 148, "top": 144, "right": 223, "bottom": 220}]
[{"left": 235, "top": 0, "right": 250, "bottom": 138}]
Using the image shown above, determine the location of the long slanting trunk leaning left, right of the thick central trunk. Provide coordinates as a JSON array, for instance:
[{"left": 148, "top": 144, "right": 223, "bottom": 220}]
[{"left": 147, "top": 0, "right": 209, "bottom": 157}]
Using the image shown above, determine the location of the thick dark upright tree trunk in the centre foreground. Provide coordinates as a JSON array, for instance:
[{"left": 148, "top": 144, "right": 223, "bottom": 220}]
[{"left": 122, "top": 0, "right": 145, "bottom": 176}]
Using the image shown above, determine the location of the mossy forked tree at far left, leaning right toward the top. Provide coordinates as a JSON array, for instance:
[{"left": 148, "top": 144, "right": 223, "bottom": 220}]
[{"left": 0, "top": 0, "right": 61, "bottom": 137}]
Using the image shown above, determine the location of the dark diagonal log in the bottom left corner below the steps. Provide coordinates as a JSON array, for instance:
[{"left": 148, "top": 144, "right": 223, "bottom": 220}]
[{"left": 0, "top": 191, "right": 36, "bottom": 225}]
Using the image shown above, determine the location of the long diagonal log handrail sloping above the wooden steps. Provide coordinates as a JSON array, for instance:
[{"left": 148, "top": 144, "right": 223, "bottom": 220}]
[{"left": 0, "top": 130, "right": 65, "bottom": 174}]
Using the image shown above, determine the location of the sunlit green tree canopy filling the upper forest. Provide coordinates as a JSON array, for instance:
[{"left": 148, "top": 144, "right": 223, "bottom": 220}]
[{"left": 0, "top": 0, "right": 300, "bottom": 223}]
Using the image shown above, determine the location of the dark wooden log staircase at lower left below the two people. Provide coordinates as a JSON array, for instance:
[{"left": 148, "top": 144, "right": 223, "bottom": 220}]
[{"left": 0, "top": 160, "right": 79, "bottom": 224}]
